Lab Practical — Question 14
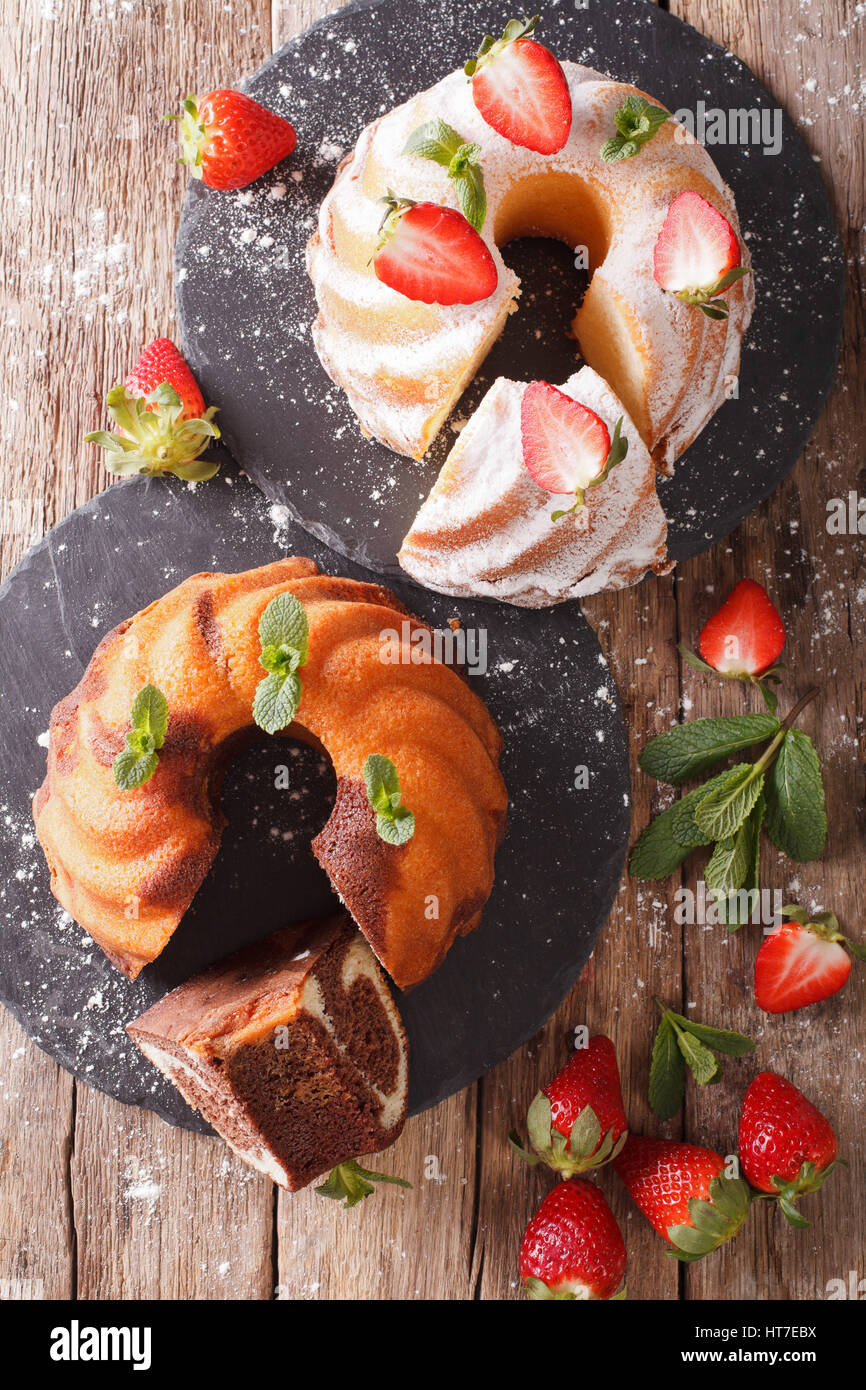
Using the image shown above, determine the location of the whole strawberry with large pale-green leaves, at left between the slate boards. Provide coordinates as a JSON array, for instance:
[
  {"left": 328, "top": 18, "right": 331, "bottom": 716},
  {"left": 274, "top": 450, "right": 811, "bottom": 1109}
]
[{"left": 85, "top": 338, "right": 220, "bottom": 482}]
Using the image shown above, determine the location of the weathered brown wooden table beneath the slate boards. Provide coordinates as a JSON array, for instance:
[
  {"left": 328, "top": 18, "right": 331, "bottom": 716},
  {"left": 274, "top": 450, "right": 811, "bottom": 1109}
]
[{"left": 0, "top": 0, "right": 866, "bottom": 1300}]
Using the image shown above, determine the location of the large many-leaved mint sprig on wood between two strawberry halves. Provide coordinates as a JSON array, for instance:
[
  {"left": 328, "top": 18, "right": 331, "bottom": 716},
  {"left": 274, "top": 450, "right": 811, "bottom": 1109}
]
[{"left": 630, "top": 688, "right": 827, "bottom": 906}]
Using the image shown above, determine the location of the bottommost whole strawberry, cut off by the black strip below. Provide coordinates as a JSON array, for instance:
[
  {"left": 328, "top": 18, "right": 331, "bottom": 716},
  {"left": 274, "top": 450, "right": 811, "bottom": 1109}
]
[{"left": 520, "top": 1177, "right": 626, "bottom": 1300}]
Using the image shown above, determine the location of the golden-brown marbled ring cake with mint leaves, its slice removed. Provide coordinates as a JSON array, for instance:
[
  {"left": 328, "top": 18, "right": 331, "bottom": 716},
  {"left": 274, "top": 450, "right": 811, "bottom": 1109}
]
[{"left": 33, "top": 559, "right": 507, "bottom": 988}]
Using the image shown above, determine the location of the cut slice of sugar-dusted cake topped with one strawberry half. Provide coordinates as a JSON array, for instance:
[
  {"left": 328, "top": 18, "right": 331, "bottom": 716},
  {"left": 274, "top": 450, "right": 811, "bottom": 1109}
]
[{"left": 398, "top": 367, "right": 670, "bottom": 607}]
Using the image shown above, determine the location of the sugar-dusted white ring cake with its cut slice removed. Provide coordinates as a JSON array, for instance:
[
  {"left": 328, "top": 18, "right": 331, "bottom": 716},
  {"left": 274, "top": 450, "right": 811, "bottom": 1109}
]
[{"left": 307, "top": 61, "right": 753, "bottom": 471}]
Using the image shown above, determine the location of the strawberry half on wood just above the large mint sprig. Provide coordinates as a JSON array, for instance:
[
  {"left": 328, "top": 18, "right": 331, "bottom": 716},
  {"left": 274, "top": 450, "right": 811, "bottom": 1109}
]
[{"left": 680, "top": 580, "right": 785, "bottom": 709}]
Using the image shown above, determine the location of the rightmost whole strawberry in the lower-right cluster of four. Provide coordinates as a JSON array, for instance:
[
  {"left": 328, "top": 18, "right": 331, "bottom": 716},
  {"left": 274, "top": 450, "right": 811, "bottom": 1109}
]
[{"left": 740, "top": 1072, "right": 842, "bottom": 1226}]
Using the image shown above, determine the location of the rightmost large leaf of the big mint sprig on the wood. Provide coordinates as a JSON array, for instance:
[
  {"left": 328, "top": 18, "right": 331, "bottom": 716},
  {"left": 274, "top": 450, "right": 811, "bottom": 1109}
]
[{"left": 765, "top": 728, "right": 827, "bottom": 863}]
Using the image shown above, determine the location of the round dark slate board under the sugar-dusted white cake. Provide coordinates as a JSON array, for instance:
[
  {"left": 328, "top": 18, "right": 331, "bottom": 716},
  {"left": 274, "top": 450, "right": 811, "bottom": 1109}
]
[{"left": 175, "top": 0, "right": 844, "bottom": 575}]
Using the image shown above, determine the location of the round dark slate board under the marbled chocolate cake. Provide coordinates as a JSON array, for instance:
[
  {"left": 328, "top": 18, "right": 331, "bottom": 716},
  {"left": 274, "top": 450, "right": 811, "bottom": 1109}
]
[{"left": 0, "top": 457, "right": 630, "bottom": 1129}]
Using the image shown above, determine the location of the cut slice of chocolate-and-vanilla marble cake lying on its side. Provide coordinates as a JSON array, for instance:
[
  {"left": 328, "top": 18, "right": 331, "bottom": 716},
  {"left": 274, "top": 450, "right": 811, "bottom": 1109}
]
[{"left": 126, "top": 913, "right": 409, "bottom": 1191}]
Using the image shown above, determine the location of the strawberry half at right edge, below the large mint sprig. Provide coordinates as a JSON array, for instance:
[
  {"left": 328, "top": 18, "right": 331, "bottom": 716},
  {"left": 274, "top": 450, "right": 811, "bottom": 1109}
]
[{"left": 755, "top": 906, "right": 866, "bottom": 1013}]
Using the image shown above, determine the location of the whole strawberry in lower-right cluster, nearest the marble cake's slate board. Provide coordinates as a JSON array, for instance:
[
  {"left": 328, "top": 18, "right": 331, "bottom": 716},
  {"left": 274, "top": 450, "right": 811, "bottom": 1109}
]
[{"left": 510, "top": 1034, "right": 628, "bottom": 1177}]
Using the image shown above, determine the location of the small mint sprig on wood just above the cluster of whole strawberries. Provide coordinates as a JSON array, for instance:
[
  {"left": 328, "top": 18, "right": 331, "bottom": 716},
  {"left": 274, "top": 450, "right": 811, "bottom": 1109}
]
[{"left": 649, "top": 999, "right": 755, "bottom": 1120}]
